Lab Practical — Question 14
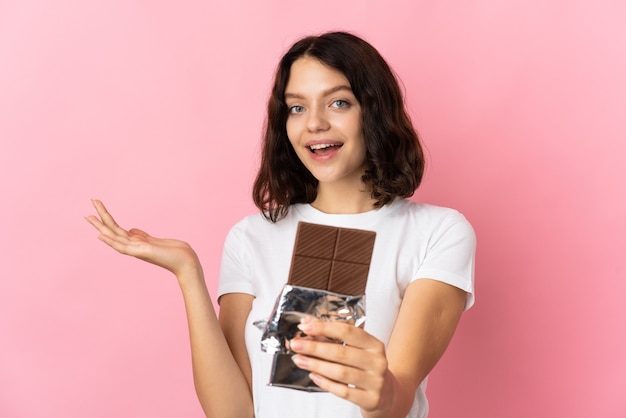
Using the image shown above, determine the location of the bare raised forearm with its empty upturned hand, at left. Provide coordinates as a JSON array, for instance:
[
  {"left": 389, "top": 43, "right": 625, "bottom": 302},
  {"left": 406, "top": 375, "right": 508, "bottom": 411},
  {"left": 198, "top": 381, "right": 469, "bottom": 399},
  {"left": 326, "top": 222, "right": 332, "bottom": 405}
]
[{"left": 86, "top": 201, "right": 253, "bottom": 418}]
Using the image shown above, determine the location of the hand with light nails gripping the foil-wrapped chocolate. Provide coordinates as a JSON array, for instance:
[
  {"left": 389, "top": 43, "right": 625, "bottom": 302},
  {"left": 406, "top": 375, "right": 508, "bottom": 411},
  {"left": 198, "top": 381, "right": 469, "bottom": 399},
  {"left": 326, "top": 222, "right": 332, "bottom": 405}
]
[{"left": 291, "top": 317, "right": 394, "bottom": 411}]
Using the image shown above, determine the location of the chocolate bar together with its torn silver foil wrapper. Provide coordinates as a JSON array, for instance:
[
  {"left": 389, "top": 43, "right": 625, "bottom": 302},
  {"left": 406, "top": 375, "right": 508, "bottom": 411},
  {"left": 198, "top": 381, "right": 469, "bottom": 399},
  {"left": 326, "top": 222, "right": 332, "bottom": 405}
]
[{"left": 261, "top": 222, "right": 376, "bottom": 391}]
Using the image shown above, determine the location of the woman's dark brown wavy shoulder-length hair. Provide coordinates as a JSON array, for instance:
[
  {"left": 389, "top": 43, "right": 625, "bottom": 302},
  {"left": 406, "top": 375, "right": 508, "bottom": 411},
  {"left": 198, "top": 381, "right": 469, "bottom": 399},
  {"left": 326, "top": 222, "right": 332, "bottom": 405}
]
[{"left": 252, "top": 32, "right": 425, "bottom": 222}]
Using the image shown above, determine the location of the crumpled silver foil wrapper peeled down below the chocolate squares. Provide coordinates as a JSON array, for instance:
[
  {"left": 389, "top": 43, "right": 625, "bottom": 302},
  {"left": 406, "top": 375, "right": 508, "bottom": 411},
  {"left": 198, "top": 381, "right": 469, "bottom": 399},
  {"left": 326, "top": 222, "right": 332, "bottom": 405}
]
[{"left": 255, "top": 285, "right": 365, "bottom": 392}]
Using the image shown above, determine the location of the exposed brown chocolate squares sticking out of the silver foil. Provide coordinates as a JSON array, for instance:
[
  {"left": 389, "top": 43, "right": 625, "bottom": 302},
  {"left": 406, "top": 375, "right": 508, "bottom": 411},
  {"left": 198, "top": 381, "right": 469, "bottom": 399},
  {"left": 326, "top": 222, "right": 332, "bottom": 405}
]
[{"left": 288, "top": 222, "right": 376, "bottom": 295}]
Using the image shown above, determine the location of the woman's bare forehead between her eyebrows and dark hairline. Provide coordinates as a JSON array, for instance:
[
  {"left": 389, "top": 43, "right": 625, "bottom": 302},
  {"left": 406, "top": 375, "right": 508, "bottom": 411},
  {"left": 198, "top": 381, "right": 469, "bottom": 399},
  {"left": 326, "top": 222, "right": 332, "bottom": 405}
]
[{"left": 285, "top": 57, "right": 351, "bottom": 95}]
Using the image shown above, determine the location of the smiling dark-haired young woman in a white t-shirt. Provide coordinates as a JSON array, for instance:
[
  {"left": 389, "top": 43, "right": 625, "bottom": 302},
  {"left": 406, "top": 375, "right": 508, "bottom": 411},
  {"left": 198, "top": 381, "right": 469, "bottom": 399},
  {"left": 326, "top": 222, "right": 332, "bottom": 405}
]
[{"left": 87, "top": 32, "right": 475, "bottom": 418}]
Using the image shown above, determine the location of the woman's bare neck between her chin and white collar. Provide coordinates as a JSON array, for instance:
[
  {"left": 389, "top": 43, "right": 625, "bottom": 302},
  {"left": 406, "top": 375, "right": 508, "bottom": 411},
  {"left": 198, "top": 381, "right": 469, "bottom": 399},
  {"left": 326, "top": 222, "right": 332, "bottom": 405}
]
[{"left": 311, "top": 184, "right": 376, "bottom": 214}]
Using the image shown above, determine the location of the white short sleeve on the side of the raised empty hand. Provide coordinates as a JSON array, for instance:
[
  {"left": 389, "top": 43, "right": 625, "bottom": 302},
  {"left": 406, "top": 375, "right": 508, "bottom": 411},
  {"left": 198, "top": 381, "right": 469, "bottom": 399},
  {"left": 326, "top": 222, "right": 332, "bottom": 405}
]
[{"left": 217, "top": 219, "right": 255, "bottom": 299}]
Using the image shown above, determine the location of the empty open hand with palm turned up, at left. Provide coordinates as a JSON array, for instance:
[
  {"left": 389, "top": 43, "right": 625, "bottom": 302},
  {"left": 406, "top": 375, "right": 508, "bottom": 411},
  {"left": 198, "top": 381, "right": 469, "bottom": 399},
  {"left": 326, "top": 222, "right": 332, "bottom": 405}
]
[{"left": 85, "top": 200, "right": 199, "bottom": 276}]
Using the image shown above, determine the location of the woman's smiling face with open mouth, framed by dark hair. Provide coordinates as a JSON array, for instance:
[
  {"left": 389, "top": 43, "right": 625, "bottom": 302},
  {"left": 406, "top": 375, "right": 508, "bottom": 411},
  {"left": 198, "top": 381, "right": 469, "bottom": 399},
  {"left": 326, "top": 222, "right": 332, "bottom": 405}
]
[{"left": 285, "top": 57, "right": 366, "bottom": 187}]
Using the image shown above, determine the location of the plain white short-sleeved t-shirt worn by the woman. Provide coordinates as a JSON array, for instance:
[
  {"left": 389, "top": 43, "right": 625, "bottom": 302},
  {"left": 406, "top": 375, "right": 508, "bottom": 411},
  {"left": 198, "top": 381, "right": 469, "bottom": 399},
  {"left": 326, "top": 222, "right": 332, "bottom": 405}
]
[{"left": 218, "top": 199, "right": 475, "bottom": 418}]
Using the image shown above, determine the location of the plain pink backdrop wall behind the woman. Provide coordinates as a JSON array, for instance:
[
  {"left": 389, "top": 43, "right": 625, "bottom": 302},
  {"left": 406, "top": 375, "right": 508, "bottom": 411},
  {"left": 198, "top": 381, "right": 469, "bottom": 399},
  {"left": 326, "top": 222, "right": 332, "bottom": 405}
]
[{"left": 0, "top": 0, "right": 626, "bottom": 418}]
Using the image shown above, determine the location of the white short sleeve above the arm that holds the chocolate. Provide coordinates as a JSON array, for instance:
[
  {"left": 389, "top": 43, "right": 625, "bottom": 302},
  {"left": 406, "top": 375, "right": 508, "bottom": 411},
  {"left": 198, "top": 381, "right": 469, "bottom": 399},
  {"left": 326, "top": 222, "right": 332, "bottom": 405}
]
[{"left": 413, "top": 211, "right": 476, "bottom": 309}]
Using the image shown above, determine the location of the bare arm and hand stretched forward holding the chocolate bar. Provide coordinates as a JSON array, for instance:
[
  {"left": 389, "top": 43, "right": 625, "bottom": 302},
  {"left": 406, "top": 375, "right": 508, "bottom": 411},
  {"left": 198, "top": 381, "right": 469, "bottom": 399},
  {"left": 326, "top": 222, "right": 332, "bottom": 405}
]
[{"left": 291, "top": 279, "right": 466, "bottom": 418}]
